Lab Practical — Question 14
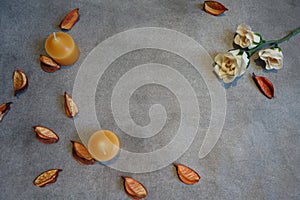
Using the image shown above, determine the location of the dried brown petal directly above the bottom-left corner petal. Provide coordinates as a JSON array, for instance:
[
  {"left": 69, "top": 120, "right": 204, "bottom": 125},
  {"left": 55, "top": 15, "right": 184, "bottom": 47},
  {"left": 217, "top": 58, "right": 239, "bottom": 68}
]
[{"left": 33, "top": 126, "right": 59, "bottom": 144}]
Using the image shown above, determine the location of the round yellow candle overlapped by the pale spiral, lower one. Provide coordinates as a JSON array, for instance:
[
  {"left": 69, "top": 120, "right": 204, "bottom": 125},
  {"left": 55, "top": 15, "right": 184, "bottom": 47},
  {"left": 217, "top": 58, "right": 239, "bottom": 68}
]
[{"left": 88, "top": 130, "right": 120, "bottom": 162}]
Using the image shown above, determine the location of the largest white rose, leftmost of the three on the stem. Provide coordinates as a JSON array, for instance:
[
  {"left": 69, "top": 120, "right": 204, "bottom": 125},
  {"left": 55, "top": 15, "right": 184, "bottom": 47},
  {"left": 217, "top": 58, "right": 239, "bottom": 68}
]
[{"left": 214, "top": 49, "right": 249, "bottom": 83}]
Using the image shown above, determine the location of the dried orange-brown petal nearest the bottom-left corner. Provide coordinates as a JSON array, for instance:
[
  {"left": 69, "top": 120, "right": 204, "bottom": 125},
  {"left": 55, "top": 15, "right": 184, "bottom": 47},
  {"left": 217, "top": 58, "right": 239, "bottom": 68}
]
[{"left": 33, "top": 169, "right": 62, "bottom": 187}]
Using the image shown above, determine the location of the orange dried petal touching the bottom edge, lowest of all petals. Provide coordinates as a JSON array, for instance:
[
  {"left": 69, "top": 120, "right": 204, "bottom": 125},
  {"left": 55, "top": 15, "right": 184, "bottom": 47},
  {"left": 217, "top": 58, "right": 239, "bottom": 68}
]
[{"left": 123, "top": 177, "right": 147, "bottom": 199}]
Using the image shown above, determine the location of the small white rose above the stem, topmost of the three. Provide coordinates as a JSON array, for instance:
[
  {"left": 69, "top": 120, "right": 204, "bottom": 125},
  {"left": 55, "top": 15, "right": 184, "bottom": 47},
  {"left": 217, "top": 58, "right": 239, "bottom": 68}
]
[{"left": 234, "top": 24, "right": 261, "bottom": 49}]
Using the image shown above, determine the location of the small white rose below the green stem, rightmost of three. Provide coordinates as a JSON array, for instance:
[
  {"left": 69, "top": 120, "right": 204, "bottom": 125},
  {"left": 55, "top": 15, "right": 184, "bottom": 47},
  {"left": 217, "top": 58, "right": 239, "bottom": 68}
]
[{"left": 258, "top": 48, "right": 283, "bottom": 70}]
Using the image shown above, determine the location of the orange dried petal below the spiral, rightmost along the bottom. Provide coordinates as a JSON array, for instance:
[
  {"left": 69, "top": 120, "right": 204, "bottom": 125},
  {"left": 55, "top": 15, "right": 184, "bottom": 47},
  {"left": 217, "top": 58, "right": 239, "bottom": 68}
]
[{"left": 174, "top": 164, "right": 200, "bottom": 185}]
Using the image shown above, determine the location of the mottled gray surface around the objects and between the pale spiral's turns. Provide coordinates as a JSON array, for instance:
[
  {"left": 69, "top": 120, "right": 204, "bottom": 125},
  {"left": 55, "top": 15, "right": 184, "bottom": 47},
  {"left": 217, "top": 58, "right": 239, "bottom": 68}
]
[{"left": 0, "top": 0, "right": 300, "bottom": 199}]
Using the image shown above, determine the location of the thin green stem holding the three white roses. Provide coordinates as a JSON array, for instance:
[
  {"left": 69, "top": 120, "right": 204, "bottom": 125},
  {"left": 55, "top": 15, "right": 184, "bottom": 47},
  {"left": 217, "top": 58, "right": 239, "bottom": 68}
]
[{"left": 246, "top": 27, "right": 300, "bottom": 58}]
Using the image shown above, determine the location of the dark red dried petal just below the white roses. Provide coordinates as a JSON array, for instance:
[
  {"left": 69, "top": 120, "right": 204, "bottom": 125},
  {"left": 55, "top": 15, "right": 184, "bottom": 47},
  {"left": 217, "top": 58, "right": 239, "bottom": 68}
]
[{"left": 252, "top": 73, "right": 274, "bottom": 99}]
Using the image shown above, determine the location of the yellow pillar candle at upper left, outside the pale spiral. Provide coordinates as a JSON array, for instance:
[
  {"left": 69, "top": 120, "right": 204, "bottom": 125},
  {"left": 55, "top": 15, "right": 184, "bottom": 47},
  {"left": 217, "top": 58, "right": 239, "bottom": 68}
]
[{"left": 45, "top": 32, "right": 80, "bottom": 66}]
